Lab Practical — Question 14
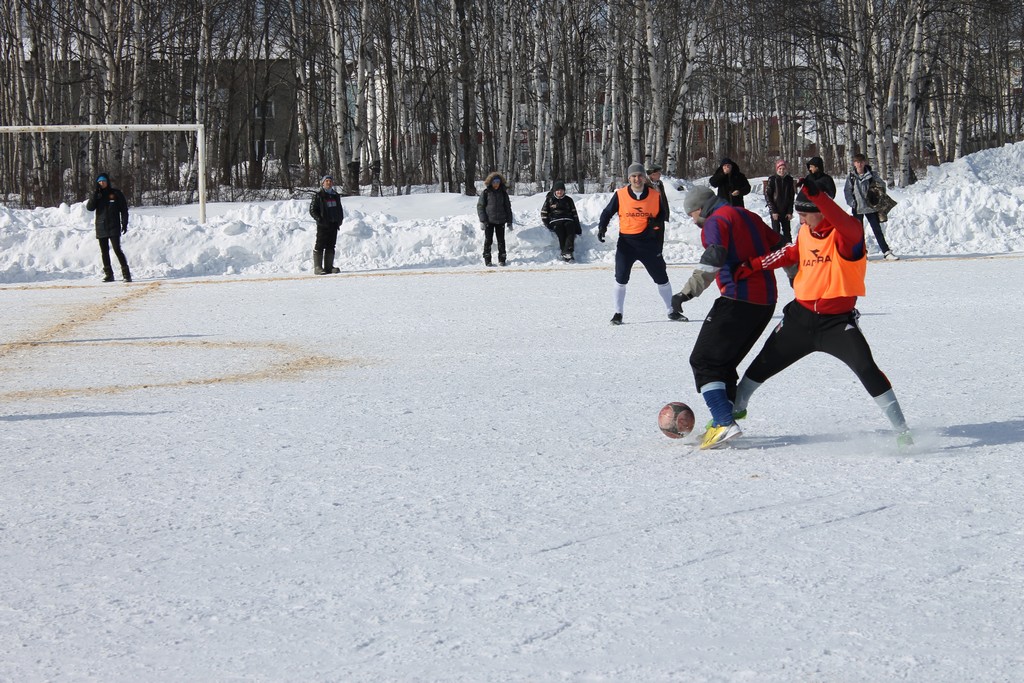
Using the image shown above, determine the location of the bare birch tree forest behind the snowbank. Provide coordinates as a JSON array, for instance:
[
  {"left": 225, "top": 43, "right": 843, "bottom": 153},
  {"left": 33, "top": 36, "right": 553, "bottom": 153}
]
[{"left": 0, "top": 0, "right": 1024, "bottom": 207}]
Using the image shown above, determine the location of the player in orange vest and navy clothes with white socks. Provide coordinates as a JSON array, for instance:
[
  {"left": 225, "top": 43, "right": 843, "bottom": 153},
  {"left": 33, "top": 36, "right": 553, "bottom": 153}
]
[{"left": 597, "top": 164, "right": 686, "bottom": 325}]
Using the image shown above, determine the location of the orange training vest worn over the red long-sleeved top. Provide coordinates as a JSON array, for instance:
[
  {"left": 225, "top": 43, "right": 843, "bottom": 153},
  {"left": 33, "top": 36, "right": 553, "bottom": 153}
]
[{"left": 793, "top": 224, "right": 867, "bottom": 301}]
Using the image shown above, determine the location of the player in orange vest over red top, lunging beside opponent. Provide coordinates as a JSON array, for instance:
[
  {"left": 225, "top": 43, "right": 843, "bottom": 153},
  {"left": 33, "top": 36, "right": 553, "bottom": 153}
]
[{"left": 733, "top": 178, "right": 913, "bottom": 447}]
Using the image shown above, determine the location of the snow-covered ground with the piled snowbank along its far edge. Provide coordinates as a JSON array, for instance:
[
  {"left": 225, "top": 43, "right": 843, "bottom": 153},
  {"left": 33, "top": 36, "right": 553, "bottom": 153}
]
[{"left": 0, "top": 145, "right": 1024, "bottom": 683}]
